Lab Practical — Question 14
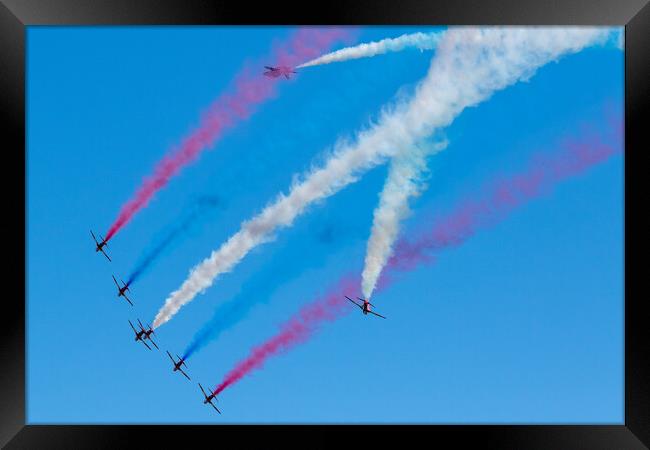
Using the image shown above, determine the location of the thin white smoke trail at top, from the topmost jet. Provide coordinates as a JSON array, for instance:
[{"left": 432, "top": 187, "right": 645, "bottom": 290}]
[{"left": 296, "top": 32, "right": 444, "bottom": 69}]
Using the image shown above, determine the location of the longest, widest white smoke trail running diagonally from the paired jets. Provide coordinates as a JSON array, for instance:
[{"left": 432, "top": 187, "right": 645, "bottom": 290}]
[{"left": 153, "top": 27, "right": 608, "bottom": 328}]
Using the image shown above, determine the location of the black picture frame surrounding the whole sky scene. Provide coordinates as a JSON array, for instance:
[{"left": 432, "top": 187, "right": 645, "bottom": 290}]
[{"left": 0, "top": 0, "right": 650, "bottom": 450}]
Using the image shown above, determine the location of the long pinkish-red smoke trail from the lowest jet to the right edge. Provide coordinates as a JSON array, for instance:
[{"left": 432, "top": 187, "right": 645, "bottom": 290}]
[{"left": 214, "top": 121, "right": 622, "bottom": 394}]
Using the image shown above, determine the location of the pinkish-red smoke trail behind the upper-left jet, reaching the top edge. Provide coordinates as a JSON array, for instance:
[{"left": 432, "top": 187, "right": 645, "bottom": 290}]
[{"left": 106, "top": 28, "right": 349, "bottom": 241}]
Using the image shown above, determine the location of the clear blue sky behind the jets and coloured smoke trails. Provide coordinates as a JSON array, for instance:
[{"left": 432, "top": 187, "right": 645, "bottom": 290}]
[{"left": 26, "top": 27, "right": 624, "bottom": 423}]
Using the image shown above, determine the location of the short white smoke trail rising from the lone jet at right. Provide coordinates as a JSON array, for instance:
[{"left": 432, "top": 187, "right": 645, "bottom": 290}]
[{"left": 361, "top": 141, "right": 447, "bottom": 299}]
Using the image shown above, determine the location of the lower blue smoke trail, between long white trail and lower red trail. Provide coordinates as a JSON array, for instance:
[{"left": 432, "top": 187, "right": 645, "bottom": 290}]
[{"left": 183, "top": 223, "right": 356, "bottom": 359}]
